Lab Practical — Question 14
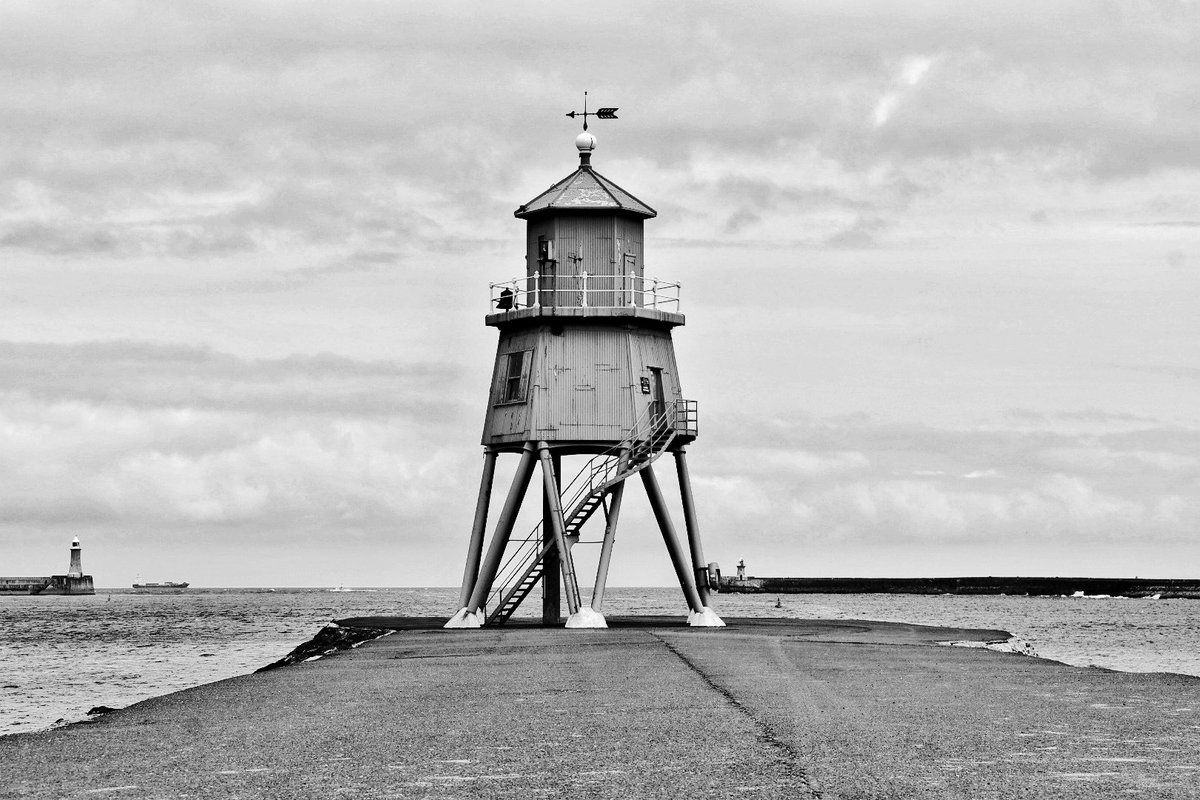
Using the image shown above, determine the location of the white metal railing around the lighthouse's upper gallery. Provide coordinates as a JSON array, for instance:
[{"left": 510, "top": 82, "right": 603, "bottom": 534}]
[{"left": 491, "top": 272, "right": 679, "bottom": 313}]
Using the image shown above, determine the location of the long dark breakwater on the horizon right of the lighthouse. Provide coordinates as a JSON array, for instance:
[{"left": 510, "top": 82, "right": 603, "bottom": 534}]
[{"left": 720, "top": 576, "right": 1200, "bottom": 600}]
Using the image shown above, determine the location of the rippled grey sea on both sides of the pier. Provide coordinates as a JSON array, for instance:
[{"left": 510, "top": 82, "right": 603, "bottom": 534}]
[{"left": 0, "top": 588, "right": 1200, "bottom": 735}]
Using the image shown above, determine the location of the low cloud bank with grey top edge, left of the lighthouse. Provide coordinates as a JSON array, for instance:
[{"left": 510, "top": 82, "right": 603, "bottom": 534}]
[{"left": 0, "top": 342, "right": 478, "bottom": 539}]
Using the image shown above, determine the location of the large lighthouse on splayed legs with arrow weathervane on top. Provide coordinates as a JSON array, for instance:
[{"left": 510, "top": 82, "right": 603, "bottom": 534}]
[{"left": 446, "top": 117, "right": 724, "bottom": 627}]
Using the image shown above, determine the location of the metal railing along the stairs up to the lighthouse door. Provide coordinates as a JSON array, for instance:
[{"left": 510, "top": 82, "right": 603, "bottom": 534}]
[{"left": 484, "top": 399, "right": 698, "bottom": 615}]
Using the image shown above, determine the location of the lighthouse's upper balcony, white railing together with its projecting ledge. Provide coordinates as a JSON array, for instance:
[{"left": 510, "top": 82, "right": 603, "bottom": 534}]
[{"left": 487, "top": 272, "right": 684, "bottom": 326}]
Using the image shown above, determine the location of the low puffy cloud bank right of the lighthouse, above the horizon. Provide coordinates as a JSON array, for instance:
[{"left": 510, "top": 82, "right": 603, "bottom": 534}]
[{"left": 692, "top": 417, "right": 1200, "bottom": 540}]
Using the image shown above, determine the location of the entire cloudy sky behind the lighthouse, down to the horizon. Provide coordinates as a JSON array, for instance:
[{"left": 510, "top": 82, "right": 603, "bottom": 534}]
[{"left": 0, "top": 0, "right": 1200, "bottom": 587}]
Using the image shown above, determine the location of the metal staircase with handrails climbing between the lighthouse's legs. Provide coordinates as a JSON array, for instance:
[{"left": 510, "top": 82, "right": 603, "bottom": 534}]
[{"left": 484, "top": 399, "right": 697, "bottom": 625}]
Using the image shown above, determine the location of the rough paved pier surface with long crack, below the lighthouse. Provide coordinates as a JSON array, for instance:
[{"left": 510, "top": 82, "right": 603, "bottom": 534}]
[{"left": 0, "top": 618, "right": 1200, "bottom": 800}]
